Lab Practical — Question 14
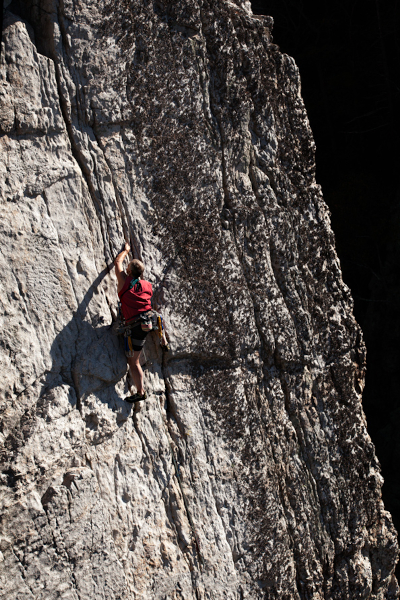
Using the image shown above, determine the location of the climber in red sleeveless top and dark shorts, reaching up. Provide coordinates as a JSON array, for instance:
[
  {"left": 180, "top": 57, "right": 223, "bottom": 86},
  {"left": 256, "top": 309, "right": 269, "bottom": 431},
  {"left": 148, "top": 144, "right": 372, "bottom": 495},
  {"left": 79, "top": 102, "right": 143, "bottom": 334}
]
[{"left": 114, "top": 244, "right": 153, "bottom": 403}]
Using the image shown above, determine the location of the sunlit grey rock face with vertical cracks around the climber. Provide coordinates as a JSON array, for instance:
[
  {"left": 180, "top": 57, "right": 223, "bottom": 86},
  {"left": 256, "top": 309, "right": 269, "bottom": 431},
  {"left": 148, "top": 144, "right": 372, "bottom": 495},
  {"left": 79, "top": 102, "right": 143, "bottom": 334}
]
[{"left": 0, "top": 0, "right": 398, "bottom": 600}]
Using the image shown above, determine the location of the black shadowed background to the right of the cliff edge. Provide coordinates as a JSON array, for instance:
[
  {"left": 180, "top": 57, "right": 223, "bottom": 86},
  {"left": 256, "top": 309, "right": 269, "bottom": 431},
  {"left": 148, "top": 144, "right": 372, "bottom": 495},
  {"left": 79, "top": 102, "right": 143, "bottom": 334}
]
[{"left": 252, "top": 0, "right": 400, "bottom": 568}]
